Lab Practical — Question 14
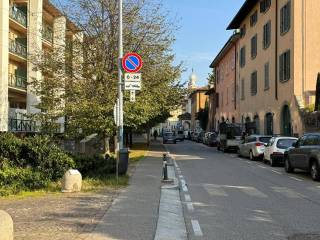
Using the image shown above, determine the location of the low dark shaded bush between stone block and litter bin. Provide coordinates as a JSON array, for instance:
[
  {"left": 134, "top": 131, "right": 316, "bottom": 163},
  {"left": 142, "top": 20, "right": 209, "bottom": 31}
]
[{"left": 72, "top": 154, "right": 116, "bottom": 177}]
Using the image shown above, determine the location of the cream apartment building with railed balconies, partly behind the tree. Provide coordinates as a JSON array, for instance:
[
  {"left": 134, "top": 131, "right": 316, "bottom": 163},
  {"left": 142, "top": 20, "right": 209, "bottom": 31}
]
[{"left": 0, "top": 0, "right": 82, "bottom": 132}]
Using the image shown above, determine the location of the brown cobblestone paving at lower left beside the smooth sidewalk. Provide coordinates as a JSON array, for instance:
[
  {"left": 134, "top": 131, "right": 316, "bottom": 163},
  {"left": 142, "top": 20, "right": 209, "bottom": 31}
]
[{"left": 0, "top": 189, "right": 119, "bottom": 240}]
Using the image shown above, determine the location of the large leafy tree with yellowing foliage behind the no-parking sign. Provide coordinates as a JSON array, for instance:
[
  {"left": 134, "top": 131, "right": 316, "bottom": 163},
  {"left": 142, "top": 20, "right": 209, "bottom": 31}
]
[{"left": 33, "top": 0, "right": 184, "bottom": 152}]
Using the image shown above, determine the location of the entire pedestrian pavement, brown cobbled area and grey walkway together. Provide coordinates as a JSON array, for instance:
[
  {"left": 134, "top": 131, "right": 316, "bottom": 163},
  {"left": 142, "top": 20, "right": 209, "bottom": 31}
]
[{"left": 0, "top": 143, "right": 164, "bottom": 240}]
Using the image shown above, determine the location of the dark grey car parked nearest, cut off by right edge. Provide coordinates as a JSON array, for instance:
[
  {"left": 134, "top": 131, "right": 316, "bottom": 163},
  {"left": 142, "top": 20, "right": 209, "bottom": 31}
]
[{"left": 284, "top": 133, "right": 320, "bottom": 181}]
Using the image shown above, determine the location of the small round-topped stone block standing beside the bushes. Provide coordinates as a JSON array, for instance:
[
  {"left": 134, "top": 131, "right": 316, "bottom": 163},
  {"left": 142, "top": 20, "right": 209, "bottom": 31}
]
[{"left": 62, "top": 169, "right": 82, "bottom": 193}]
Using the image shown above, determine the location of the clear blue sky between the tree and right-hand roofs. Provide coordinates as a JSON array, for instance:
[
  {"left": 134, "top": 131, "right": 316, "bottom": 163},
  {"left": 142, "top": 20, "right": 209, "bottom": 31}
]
[{"left": 163, "top": 0, "right": 244, "bottom": 86}]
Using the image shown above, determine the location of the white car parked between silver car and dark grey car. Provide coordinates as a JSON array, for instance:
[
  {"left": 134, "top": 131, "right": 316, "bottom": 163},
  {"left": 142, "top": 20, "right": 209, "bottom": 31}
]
[{"left": 263, "top": 137, "right": 298, "bottom": 167}]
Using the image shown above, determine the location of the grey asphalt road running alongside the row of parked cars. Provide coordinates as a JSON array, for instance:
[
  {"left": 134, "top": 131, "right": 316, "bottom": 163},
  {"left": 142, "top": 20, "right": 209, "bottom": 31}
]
[{"left": 166, "top": 141, "right": 320, "bottom": 240}]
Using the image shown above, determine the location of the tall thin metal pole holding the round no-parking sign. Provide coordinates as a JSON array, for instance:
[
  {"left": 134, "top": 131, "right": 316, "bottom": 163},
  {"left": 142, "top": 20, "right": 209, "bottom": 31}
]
[{"left": 116, "top": 0, "right": 123, "bottom": 181}]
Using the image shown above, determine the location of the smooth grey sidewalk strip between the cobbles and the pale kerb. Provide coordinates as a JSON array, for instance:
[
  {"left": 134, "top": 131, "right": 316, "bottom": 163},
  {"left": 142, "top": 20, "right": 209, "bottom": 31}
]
[{"left": 78, "top": 142, "right": 165, "bottom": 240}]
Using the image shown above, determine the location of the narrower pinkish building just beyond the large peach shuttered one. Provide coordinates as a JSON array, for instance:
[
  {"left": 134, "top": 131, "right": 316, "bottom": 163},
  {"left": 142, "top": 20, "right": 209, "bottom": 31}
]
[{"left": 210, "top": 31, "right": 240, "bottom": 130}]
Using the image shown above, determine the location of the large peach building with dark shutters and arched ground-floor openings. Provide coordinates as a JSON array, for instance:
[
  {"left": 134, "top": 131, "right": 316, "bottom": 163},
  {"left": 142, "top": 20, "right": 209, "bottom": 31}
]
[{"left": 227, "top": 0, "right": 320, "bottom": 135}]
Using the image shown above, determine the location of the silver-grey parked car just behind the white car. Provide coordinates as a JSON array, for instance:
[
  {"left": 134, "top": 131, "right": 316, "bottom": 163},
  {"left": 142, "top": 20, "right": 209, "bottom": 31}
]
[{"left": 238, "top": 135, "right": 272, "bottom": 160}]
